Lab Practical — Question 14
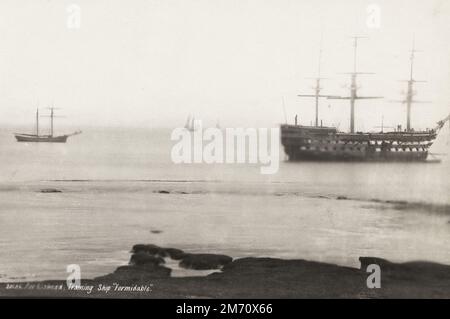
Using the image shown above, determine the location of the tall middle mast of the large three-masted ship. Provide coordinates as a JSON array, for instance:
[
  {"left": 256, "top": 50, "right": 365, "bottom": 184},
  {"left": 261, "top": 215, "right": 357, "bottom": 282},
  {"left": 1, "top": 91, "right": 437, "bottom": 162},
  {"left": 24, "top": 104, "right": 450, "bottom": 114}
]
[{"left": 329, "top": 36, "right": 383, "bottom": 133}]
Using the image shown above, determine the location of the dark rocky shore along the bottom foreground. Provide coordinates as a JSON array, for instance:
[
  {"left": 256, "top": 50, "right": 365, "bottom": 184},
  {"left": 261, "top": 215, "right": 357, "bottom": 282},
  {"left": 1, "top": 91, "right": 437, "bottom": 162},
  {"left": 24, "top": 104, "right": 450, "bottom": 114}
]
[{"left": 0, "top": 244, "right": 450, "bottom": 298}]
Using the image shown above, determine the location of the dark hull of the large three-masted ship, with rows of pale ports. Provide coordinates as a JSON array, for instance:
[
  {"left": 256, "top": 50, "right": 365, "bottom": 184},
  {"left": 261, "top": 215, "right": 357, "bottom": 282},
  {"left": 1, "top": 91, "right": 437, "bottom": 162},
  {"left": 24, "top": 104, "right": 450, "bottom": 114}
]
[{"left": 281, "top": 125, "right": 436, "bottom": 162}]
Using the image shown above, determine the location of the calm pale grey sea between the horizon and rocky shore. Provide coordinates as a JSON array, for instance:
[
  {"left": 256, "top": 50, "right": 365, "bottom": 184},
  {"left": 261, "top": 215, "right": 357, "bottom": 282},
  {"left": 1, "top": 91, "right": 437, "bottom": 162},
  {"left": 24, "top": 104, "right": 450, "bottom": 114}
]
[{"left": 0, "top": 128, "right": 450, "bottom": 281}]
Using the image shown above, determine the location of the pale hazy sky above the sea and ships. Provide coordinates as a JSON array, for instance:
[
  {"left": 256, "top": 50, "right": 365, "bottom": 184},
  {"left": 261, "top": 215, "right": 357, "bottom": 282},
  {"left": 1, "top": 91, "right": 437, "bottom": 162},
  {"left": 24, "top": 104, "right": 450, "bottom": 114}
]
[{"left": 0, "top": 0, "right": 450, "bottom": 130}]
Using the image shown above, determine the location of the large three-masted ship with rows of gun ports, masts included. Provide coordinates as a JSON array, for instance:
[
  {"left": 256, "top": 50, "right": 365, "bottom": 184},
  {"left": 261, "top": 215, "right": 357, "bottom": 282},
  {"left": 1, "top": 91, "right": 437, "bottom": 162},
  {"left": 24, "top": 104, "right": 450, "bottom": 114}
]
[{"left": 281, "top": 37, "right": 450, "bottom": 161}]
